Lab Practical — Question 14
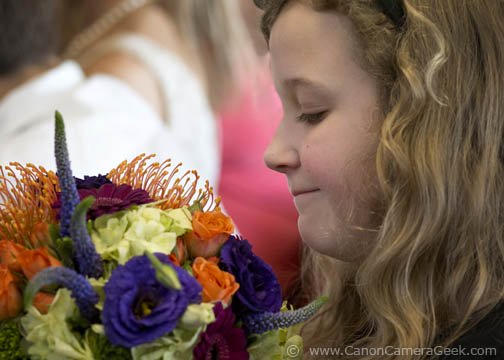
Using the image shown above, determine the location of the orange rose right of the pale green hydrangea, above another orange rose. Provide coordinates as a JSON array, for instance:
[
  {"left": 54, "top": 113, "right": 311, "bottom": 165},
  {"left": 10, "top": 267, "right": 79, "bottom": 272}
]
[{"left": 184, "top": 209, "right": 234, "bottom": 258}]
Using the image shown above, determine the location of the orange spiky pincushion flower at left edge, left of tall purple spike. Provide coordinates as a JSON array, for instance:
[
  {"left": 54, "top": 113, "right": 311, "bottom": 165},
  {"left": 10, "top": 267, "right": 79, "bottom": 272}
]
[{"left": 0, "top": 162, "right": 59, "bottom": 248}]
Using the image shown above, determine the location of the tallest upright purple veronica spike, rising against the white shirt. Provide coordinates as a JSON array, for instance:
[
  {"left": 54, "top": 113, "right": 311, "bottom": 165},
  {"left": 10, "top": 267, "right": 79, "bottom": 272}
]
[{"left": 54, "top": 111, "right": 79, "bottom": 237}]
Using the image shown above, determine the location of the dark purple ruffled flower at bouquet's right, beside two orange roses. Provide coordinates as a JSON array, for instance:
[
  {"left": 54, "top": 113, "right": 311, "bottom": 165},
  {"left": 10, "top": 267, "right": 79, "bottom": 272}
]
[{"left": 219, "top": 236, "right": 282, "bottom": 317}]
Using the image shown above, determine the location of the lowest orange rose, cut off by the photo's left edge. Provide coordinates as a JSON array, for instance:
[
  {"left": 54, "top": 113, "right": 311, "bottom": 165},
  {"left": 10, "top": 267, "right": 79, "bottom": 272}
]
[{"left": 0, "top": 264, "right": 23, "bottom": 321}]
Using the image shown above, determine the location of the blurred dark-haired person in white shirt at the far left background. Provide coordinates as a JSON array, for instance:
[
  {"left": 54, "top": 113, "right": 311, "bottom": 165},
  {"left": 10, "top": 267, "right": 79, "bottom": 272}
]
[{"left": 0, "top": 0, "right": 178, "bottom": 176}]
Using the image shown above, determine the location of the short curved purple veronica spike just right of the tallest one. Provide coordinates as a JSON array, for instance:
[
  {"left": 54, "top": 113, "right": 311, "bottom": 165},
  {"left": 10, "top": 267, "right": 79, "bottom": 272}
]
[{"left": 70, "top": 196, "right": 103, "bottom": 278}]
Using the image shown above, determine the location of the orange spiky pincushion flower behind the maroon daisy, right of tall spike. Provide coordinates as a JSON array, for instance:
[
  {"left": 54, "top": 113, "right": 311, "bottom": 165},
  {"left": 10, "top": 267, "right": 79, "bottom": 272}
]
[{"left": 107, "top": 154, "right": 220, "bottom": 211}]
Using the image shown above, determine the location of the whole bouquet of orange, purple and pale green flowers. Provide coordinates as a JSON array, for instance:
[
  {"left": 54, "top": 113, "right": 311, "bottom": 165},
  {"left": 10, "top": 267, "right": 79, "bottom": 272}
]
[{"left": 0, "top": 113, "right": 326, "bottom": 360}]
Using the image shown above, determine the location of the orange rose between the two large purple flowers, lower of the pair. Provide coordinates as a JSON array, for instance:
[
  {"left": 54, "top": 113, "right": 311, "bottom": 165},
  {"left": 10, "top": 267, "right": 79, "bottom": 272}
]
[{"left": 192, "top": 257, "right": 240, "bottom": 305}]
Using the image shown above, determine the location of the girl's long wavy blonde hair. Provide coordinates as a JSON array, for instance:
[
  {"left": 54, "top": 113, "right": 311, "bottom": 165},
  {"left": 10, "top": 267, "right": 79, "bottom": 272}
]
[{"left": 256, "top": 0, "right": 504, "bottom": 360}]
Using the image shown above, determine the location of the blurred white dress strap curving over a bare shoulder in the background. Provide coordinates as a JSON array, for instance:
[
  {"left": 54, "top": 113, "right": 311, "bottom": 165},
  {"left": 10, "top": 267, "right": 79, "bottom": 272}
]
[{"left": 76, "top": 33, "right": 220, "bottom": 186}]
